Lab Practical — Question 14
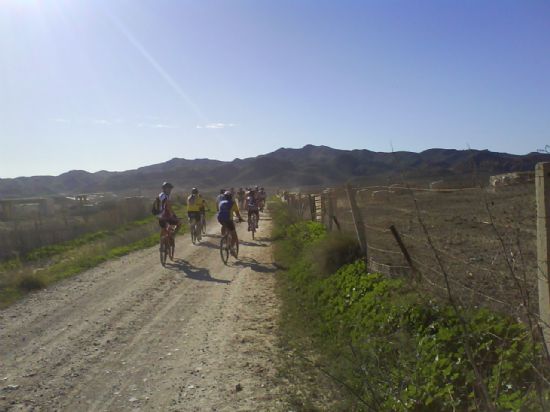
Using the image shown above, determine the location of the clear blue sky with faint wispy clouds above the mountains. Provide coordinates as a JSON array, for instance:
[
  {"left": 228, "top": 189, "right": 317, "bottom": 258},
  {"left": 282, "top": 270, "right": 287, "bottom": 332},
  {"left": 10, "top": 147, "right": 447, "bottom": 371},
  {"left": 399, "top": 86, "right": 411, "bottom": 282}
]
[{"left": 0, "top": 0, "right": 550, "bottom": 177}]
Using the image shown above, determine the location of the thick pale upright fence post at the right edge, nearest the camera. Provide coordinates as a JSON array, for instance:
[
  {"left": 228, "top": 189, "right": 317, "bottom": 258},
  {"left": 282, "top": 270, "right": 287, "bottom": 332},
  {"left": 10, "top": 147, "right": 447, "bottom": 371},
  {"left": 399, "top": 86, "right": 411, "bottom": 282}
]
[{"left": 535, "top": 162, "right": 550, "bottom": 348}]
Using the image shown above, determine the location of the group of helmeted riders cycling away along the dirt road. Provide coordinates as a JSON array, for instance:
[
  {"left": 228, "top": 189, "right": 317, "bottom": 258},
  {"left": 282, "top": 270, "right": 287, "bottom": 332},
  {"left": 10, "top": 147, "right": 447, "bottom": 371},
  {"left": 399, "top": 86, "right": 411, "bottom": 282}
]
[{"left": 157, "top": 182, "right": 267, "bottom": 258}]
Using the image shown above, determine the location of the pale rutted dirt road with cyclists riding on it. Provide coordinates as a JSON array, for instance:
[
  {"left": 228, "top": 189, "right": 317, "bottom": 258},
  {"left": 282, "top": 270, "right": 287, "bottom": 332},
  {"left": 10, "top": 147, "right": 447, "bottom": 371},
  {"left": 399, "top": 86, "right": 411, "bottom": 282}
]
[{"left": 0, "top": 214, "right": 283, "bottom": 411}]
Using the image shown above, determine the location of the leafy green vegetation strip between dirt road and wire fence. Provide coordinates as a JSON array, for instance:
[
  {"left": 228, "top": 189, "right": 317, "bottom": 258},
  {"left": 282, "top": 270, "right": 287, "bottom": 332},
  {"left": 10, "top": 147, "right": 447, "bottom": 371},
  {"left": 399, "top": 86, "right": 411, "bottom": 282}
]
[{"left": 271, "top": 203, "right": 548, "bottom": 411}]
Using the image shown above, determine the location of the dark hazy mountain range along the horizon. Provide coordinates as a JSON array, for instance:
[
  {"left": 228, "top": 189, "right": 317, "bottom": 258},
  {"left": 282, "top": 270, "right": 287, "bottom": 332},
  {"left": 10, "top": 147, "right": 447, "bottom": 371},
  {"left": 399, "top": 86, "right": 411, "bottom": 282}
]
[{"left": 0, "top": 145, "right": 550, "bottom": 198}]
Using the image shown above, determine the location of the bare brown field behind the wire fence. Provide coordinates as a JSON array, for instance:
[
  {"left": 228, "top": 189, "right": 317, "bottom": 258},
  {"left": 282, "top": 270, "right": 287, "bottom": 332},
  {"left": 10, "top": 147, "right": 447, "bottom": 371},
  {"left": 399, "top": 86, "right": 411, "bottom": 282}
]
[{"left": 285, "top": 182, "right": 538, "bottom": 318}]
